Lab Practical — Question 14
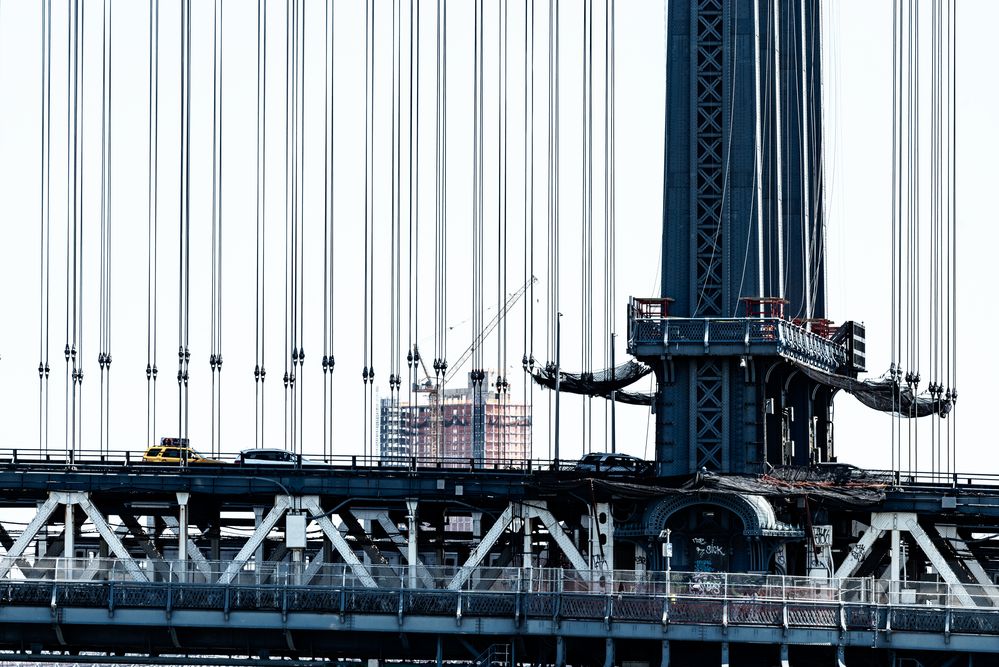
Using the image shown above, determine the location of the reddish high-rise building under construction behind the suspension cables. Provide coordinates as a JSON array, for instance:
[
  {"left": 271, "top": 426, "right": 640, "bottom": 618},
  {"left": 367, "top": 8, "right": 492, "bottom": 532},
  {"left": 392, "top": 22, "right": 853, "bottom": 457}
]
[{"left": 378, "top": 373, "right": 531, "bottom": 466}]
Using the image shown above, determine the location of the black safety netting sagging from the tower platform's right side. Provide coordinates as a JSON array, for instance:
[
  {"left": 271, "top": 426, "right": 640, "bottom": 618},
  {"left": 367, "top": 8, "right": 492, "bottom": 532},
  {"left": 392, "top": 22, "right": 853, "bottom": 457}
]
[{"left": 797, "top": 364, "right": 954, "bottom": 417}]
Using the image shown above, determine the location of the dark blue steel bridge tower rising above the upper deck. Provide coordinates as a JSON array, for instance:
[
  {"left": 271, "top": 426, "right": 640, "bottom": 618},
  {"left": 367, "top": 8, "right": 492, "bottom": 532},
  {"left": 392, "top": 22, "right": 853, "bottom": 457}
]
[{"left": 629, "top": 0, "right": 855, "bottom": 475}]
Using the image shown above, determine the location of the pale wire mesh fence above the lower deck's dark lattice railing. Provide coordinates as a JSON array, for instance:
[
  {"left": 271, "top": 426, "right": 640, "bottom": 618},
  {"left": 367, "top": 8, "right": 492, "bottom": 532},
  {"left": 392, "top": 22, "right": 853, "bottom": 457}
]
[{"left": 0, "top": 556, "right": 999, "bottom": 609}]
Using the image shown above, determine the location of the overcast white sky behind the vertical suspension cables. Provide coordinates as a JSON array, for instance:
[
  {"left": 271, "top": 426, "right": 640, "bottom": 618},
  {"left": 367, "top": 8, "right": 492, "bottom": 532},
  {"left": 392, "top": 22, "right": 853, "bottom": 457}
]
[{"left": 0, "top": 0, "right": 999, "bottom": 472}]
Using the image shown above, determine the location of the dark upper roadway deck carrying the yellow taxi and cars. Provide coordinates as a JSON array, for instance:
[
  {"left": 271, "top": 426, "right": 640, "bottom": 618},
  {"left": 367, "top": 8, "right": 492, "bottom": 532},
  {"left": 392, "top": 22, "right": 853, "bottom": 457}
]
[{"left": 0, "top": 451, "right": 999, "bottom": 528}]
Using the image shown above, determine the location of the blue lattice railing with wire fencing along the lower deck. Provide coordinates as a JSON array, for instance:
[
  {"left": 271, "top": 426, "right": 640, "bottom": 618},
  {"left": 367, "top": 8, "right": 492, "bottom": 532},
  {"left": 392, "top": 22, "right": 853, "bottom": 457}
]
[{"left": 0, "top": 559, "right": 999, "bottom": 635}]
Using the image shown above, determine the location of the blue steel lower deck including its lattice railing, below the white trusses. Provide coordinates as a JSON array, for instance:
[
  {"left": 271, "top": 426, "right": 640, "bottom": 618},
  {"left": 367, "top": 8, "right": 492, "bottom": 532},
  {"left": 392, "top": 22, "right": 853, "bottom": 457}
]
[{"left": 0, "top": 570, "right": 999, "bottom": 664}]
